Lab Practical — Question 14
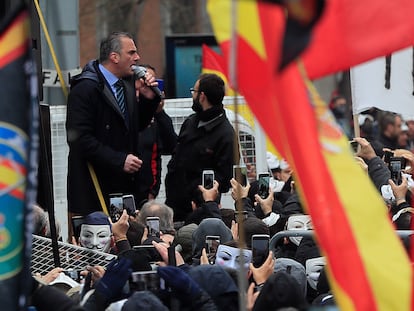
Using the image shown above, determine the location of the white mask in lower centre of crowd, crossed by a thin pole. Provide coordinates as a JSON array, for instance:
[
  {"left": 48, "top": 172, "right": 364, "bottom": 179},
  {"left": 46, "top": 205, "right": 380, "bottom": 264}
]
[{"left": 215, "top": 244, "right": 252, "bottom": 270}]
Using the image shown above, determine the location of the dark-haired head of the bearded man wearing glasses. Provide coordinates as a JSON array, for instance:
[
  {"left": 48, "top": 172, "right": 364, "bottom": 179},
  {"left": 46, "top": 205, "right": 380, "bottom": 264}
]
[{"left": 192, "top": 73, "right": 225, "bottom": 112}]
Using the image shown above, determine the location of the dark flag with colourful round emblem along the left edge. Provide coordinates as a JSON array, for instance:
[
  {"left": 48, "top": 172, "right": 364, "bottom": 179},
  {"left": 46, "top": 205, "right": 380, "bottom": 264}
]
[{"left": 0, "top": 7, "right": 38, "bottom": 310}]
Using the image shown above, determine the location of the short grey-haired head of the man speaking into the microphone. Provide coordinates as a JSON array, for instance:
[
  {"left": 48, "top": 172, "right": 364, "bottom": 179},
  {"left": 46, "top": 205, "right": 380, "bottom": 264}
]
[{"left": 99, "top": 32, "right": 140, "bottom": 78}]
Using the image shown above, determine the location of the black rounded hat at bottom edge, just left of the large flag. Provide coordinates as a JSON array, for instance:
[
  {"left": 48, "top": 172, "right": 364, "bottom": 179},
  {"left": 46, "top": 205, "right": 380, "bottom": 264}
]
[{"left": 253, "top": 271, "right": 307, "bottom": 311}]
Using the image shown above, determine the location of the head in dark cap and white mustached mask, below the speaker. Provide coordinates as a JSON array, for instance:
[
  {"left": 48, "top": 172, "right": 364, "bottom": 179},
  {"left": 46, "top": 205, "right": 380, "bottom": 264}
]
[{"left": 79, "top": 212, "right": 112, "bottom": 252}]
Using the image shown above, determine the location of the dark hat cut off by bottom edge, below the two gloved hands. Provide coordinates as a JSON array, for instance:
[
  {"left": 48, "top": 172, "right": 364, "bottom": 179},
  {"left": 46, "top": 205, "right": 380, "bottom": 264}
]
[{"left": 121, "top": 291, "right": 168, "bottom": 311}]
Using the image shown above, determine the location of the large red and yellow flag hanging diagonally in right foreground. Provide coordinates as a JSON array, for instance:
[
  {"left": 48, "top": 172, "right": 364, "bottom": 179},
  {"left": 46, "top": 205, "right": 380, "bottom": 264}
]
[{"left": 208, "top": 0, "right": 412, "bottom": 310}]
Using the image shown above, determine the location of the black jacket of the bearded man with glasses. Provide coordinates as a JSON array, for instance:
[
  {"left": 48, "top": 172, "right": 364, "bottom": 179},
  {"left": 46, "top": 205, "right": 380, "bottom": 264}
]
[{"left": 165, "top": 112, "right": 238, "bottom": 220}]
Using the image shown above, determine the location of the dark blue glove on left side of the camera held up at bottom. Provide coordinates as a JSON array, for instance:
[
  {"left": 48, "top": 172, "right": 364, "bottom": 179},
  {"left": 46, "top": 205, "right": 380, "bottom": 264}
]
[{"left": 95, "top": 258, "right": 132, "bottom": 302}]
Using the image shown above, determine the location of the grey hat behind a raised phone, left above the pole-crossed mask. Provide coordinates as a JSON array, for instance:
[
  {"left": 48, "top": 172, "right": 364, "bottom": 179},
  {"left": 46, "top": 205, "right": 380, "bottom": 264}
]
[{"left": 192, "top": 218, "right": 233, "bottom": 258}]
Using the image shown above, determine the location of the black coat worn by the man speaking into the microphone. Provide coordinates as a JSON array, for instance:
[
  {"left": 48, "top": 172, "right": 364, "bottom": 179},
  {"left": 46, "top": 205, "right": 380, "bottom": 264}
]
[{"left": 66, "top": 61, "right": 160, "bottom": 215}]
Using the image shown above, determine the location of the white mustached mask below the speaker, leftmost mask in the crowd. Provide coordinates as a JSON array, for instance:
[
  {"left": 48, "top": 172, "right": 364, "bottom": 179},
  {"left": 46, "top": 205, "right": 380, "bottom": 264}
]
[{"left": 79, "top": 224, "right": 112, "bottom": 252}]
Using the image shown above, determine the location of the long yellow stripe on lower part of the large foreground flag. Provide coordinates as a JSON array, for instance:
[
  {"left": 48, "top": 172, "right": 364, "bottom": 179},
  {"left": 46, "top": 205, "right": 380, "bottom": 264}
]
[{"left": 307, "top": 76, "right": 412, "bottom": 310}]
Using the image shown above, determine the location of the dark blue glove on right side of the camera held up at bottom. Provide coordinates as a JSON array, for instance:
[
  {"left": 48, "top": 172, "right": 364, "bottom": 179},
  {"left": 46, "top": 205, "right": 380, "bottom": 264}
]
[{"left": 158, "top": 266, "right": 202, "bottom": 299}]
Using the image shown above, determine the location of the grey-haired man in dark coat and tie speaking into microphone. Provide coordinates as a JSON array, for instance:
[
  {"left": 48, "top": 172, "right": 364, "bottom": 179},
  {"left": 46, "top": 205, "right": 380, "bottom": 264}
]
[{"left": 66, "top": 32, "right": 161, "bottom": 215}]
